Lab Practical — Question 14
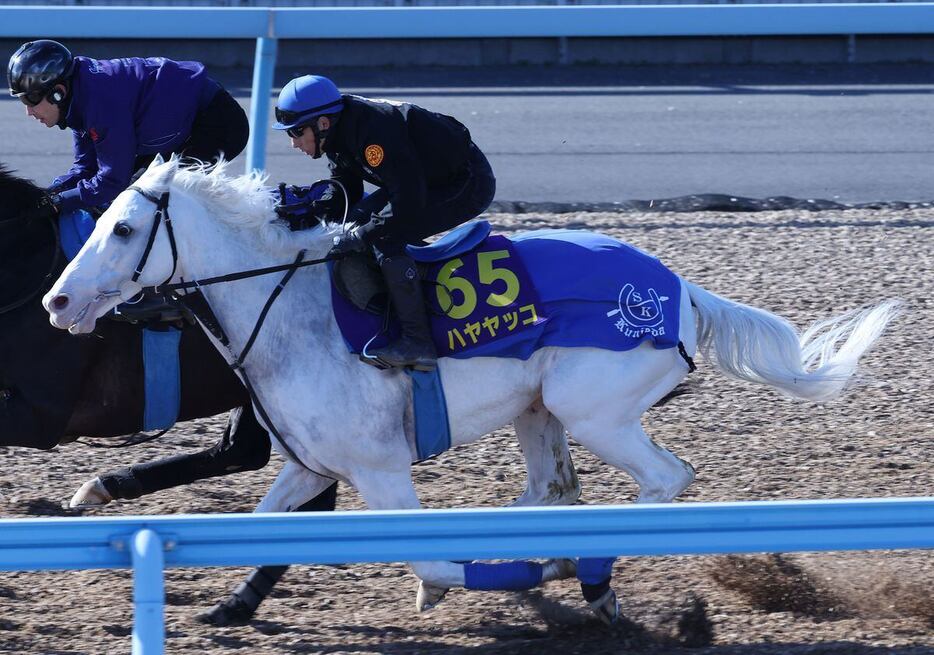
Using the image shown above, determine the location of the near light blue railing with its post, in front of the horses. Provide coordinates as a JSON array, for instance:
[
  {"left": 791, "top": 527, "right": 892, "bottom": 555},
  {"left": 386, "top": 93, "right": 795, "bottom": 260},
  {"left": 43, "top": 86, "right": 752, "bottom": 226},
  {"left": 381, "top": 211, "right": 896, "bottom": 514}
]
[{"left": 0, "top": 498, "right": 934, "bottom": 655}]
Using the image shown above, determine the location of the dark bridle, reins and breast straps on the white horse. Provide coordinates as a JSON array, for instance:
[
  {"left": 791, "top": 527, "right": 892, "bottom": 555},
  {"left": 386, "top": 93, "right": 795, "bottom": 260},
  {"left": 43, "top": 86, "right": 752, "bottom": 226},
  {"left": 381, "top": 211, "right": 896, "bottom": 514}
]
[{"left": 128, "top": 186, "right": 336, "bottom": 478}]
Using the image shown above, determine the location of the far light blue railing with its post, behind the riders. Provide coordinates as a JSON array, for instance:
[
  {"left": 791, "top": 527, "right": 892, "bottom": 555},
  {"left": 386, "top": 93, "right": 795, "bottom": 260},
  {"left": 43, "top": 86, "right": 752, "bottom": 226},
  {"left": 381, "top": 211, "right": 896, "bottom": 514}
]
[{"left": 0, "top": 2, "right": 934, "bottom": 169}]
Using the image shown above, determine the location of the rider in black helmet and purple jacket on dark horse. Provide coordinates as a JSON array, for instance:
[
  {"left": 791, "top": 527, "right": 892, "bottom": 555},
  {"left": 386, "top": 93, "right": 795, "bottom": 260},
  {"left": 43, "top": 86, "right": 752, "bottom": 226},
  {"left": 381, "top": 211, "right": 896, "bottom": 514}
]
[{"left": 7, "top": 40, "right": 249, "bottom": 211}]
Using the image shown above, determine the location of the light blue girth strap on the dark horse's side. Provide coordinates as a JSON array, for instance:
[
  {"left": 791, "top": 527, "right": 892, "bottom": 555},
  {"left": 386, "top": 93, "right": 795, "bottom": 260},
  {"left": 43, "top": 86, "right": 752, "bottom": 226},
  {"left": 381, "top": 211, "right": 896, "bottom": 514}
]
[{"left": 143, "top": 328, "right": 182, "bottom": 430}]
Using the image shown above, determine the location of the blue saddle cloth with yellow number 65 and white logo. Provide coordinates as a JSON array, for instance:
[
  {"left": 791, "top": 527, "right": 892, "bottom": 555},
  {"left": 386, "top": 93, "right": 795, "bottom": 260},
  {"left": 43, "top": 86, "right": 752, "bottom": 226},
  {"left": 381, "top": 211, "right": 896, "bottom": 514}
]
[{"left": 332, "top": 221, "right": 681, "bottom": 359}]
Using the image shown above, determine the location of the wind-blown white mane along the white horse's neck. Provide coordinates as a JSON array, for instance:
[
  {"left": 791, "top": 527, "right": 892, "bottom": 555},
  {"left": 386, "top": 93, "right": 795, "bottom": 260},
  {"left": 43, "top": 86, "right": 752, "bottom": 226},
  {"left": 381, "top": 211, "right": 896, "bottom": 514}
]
[{"left": 137, "top": 155, "right": 341, "bottom": 250}]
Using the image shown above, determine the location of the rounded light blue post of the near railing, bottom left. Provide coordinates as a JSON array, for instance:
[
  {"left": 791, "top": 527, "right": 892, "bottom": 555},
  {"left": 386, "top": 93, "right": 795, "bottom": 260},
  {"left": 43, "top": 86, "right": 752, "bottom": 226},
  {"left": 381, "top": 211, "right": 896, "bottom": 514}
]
[{"left": 130, "top": 528, "right": 165, "bottom": 655}]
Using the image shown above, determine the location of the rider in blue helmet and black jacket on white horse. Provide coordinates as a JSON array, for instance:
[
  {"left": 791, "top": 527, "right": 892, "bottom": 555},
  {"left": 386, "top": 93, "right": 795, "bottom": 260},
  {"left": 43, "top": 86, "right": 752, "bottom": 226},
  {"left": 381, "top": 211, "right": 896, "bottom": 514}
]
[{"left": 272, "top": 75, "right": 496, "bottom": 370}]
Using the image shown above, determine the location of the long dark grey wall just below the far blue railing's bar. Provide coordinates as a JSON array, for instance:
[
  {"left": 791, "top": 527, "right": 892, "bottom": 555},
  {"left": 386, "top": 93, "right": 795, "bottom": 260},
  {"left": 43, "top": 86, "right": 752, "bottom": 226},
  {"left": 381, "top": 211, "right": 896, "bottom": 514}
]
[{"left": 0, "top": 35, "right": 934, "bottom": 69}]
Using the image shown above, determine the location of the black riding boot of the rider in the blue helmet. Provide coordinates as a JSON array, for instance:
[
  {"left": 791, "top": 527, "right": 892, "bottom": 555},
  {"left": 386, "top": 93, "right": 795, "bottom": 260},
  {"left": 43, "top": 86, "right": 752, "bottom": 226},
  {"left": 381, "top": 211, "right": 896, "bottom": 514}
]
[{"left": 372, "top": 255, "right": 438, "bottom": 371}]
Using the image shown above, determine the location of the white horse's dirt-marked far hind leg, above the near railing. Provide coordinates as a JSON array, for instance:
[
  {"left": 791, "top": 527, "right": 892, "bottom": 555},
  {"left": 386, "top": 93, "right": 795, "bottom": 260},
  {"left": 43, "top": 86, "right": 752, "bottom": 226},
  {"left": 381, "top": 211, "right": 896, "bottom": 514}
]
[{"left": 513, "top": 399, "right": 581, "bottom": 506}]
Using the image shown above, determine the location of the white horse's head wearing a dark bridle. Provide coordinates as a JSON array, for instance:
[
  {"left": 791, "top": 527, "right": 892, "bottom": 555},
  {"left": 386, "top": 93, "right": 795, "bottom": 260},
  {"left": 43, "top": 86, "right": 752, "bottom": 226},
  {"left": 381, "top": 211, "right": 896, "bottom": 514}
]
[{"left": 42, "top": 157, "right": 178, "bottom": 334}]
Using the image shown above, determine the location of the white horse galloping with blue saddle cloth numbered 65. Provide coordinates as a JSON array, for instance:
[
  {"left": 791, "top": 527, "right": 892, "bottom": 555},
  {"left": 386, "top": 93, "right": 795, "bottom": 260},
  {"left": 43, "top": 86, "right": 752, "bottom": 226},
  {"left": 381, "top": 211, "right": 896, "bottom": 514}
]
[{"left": 43, "top": 160, "right": 898, "bottom": 620}]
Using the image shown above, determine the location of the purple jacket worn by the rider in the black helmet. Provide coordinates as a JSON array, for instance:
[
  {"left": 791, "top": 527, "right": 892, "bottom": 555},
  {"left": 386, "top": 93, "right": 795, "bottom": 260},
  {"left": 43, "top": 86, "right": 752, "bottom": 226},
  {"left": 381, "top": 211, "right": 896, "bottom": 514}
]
[{"left": 52, "top": 57, "right": 220, "bottom": 211}]
